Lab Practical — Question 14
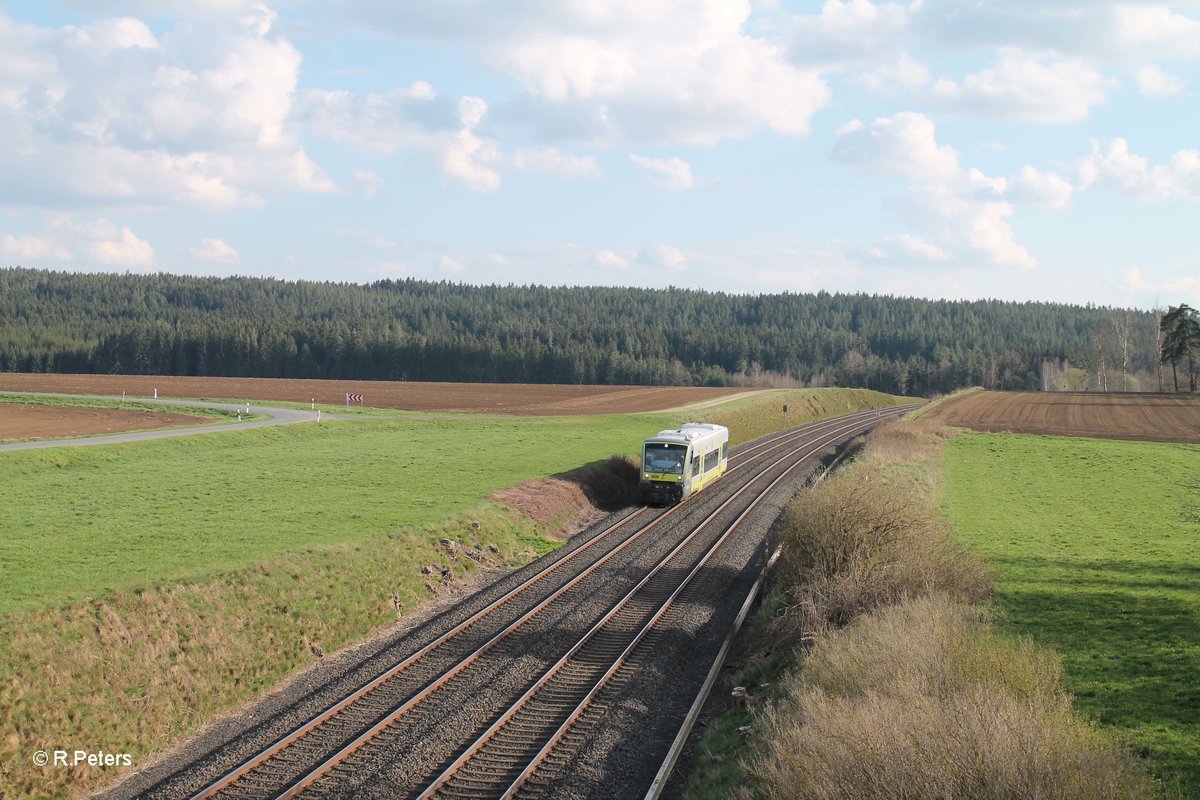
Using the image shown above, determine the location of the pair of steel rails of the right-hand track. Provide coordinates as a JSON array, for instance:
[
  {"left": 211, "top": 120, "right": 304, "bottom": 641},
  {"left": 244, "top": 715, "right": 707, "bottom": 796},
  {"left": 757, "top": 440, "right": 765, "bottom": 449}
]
[{"left": 419, "top": 417, "right": 902, "bottom": 800}]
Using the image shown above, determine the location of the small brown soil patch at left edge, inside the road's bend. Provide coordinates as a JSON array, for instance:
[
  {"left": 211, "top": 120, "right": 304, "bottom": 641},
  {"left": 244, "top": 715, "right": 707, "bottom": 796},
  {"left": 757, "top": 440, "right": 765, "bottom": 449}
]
[{"left": 0, "top": 403, "right": 212, "bottom": 441}]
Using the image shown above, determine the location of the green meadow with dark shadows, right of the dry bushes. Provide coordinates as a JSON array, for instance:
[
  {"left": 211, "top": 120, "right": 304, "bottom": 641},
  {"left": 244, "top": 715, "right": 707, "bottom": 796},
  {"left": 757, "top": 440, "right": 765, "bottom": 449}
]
[{"left": 944, "top": 434, "right": 1200, "bottom": 796}]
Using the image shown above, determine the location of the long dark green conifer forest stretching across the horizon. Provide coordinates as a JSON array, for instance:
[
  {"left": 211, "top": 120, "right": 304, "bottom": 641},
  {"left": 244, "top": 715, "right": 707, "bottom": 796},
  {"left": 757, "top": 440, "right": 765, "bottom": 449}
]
[{"left": 0, "top": 267, "right": 1180, "bottom": 395}]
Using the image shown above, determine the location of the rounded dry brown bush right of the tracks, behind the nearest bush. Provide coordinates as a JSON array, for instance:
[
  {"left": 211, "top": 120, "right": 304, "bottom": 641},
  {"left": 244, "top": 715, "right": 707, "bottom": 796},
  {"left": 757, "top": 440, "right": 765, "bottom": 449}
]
[{"left": 778, "top": 470, "right": 990, "bottom": 638}]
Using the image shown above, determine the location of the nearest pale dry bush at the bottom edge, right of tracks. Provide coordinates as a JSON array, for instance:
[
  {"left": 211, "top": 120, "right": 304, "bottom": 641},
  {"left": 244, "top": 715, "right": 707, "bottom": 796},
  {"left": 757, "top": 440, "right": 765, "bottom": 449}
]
[{"left": 749, "top": 597, "right": 1153, "bottom": 800}]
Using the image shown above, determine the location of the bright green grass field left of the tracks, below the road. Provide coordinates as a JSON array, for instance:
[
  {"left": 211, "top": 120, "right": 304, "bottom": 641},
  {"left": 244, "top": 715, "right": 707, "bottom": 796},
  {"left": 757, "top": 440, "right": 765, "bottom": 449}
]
[{"left": 0, "top": 416, "right": 686, "bottom": 614}]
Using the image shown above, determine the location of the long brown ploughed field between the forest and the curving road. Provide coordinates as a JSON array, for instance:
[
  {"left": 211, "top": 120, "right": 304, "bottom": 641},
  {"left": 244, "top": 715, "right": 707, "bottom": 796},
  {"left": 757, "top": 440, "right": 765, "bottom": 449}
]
[{"left": 0, "top": 373, "right": 746, "bottom": 415}]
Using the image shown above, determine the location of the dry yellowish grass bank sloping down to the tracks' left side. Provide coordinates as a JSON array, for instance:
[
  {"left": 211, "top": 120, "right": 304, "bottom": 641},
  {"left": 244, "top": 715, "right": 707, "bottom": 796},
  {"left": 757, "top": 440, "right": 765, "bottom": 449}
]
[{"left": 0, "top": 505, "right": 557, "bottom": 798}]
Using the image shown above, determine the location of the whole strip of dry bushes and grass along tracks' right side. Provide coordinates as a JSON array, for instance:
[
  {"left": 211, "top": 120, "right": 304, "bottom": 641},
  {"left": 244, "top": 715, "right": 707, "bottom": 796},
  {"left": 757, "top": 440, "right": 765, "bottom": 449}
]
[{"left": 685, "top": 422, "right": 1154, "bottom": 800}]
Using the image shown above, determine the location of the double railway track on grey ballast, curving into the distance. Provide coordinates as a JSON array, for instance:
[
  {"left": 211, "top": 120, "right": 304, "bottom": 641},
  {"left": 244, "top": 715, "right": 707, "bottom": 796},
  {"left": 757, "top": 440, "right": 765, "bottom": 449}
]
[{"left": 100, "top": 408, "right": 907, "bottom": 798}]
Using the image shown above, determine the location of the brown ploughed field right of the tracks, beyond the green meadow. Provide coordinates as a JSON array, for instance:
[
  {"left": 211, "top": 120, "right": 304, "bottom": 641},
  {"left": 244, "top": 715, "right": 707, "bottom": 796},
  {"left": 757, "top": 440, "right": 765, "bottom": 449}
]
[{"left": 929, "top": 391, "right": 1200, "bottom": 443}]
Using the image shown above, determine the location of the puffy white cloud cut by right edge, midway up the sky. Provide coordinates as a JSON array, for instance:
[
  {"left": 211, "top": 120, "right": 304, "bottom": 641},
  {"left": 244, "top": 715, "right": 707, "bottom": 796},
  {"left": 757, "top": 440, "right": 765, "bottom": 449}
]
[{"left": 1078, "top": 138, "right": 1200, "bottom": 201}]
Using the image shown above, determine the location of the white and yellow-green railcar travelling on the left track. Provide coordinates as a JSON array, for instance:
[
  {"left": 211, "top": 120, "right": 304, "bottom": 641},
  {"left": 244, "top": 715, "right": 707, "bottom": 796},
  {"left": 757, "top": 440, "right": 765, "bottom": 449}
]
[{"left": 638, "top": 422, "right": 730, "bottom": 505}]
